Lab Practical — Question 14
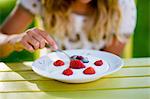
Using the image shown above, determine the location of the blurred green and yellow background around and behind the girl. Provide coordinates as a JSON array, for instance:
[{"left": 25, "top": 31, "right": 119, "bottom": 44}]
[{"left": 0, "top": 0, "right": 150, "bottom": 62}]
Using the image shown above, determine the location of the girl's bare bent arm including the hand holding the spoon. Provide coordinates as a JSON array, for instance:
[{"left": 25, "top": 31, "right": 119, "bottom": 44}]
[{"left": 0, "top": 6, "right": 57, "bottom": 57}]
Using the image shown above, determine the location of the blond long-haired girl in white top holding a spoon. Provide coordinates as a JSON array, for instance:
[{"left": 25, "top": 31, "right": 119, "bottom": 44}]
[{"left": 0, "top": 0, "right": 136, "bottom": 56}]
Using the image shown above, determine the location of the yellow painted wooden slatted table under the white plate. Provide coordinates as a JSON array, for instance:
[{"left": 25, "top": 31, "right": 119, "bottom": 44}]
[{"left": 0, "top": 58, "right": 150, "bottom": 99}]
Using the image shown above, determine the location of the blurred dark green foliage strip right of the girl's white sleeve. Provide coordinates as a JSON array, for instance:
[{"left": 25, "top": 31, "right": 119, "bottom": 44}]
[{"left": 133, "top": 0, "right": 150, "bottom": 57}]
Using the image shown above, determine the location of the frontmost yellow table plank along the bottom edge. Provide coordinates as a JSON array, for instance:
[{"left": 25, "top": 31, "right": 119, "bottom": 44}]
[{"left": 0, "top": 88, "right": 150, "bottom": 99}]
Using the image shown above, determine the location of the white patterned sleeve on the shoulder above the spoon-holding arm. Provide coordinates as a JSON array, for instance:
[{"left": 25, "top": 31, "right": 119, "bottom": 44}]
[{"left": 19, "top": 0, "right": 42, "bottom": 15}]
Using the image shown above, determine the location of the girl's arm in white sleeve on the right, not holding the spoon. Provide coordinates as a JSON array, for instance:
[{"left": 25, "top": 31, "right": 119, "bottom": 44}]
[{"left": 103, "top": 0, "right": 137, "bottom": 55}]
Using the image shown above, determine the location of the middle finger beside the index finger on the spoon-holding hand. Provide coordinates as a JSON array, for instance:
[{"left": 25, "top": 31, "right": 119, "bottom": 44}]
[{"left": 31, "top": 31, "right": 46, "bottom": 48}]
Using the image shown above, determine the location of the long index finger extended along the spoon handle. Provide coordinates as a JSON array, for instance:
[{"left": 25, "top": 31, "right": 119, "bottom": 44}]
[{"left": 34, "top": 29, "right": 58, "bottom": 49}]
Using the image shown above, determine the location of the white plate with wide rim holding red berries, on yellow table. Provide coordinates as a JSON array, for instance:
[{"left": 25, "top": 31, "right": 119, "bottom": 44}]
[{"left": 32, "top": 50, "right": 123, "bottom": 83}]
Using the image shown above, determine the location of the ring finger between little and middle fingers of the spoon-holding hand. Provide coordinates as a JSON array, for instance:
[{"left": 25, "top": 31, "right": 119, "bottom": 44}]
[{"left": 25, "top": 35, "right": 40, "bottom": 50}]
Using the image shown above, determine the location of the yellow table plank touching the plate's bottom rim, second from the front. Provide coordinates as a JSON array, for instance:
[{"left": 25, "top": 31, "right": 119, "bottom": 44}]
[{"left": 0, "top": 77, "right": 150, "bottom": 92}]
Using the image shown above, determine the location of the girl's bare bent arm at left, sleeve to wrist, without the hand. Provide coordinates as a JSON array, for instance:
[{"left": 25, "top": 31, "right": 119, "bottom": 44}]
[{"left": 0, "top": 6, "right": 34, "bottom": 57}]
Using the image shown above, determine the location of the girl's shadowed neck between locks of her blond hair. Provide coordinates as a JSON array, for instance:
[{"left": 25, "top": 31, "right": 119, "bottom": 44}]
[{"left": 72, "top": 0, "right": 91, "bottom": 15}]
